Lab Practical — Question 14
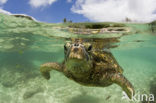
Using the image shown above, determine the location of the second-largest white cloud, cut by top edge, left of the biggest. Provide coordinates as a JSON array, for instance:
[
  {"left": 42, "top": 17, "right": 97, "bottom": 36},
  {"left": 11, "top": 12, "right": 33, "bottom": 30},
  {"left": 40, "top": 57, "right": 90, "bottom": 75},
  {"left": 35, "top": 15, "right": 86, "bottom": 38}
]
[{"left": 29, "top": 0, "right": 57, "bottom": 8}]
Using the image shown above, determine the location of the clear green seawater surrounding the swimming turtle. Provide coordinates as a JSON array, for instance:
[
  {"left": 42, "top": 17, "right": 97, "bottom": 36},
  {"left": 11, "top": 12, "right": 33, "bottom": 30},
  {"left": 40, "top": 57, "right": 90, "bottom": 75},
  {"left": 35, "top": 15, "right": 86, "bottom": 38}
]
[{"left": 0, "top": 14, "right": 156, "bottom": 103}]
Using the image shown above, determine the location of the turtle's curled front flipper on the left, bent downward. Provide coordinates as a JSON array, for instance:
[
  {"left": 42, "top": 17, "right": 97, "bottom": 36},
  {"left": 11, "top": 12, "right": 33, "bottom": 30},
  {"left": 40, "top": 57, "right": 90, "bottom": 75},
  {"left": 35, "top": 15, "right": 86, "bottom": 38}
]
[{"left": 40, "top": 62, "right": 62, "bottom": 79}]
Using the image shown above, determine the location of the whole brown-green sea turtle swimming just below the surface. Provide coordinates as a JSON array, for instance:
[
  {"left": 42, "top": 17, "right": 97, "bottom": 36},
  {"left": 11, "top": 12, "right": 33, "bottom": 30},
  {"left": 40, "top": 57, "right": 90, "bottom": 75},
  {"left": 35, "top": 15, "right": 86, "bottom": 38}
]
[{"left": 40, "top": 39, "right": 134, "bottom": 98}]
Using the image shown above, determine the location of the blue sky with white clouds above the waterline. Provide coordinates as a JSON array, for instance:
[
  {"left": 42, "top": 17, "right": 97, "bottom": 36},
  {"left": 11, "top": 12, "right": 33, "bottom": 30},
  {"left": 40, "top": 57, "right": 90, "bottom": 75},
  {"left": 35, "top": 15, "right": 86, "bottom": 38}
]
[{"left": 0, "top": 0, "right": 156, "bottom": 23}]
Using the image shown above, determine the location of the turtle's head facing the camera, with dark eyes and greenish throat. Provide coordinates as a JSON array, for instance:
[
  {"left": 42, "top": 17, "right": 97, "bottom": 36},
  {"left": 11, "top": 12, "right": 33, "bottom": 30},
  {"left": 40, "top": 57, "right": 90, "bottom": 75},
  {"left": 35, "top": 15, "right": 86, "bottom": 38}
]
[{"left": 64, "top": 42, "right": 92, "bottom": 73}]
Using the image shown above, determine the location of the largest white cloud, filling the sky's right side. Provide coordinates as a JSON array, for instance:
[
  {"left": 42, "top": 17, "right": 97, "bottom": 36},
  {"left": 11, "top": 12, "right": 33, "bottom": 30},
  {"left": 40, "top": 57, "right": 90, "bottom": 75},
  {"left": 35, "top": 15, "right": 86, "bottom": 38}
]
[{"left": 71, "top": 0, "right": 156, "bottom": 22}]
